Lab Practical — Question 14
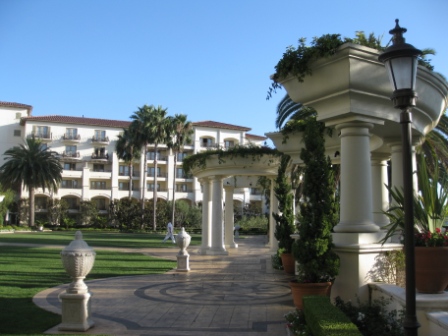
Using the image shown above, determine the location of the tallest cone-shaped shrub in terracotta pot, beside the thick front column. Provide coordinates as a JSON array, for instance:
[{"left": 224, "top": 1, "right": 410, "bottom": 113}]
[{"left": 290, "top": 117, "right": 339, "bottom": 309}]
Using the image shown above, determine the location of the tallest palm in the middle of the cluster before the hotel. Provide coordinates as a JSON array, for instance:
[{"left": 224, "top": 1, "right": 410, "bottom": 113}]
[{"left": 129, "top": 105, "right": 172, "bottom": 230}]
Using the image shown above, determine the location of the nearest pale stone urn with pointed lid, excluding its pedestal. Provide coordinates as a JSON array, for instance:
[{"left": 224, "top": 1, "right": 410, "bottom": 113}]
[{"left": 61, "top": 231, "right": 96, "bottom": 294}]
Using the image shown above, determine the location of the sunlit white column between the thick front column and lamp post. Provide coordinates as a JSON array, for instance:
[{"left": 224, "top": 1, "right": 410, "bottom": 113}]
[{"left": 371, "top": 153, "right": 389, "bottom": 228}]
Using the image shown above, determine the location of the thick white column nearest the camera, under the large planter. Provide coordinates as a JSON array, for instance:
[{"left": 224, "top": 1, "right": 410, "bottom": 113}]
[{"left": 334, "top": 122, "right": 379, "bottom": 233}]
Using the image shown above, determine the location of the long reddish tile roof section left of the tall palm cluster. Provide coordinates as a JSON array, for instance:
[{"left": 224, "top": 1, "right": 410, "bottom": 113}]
[{"left": 20, "top": 115, "right": 131, "bottom": 128}]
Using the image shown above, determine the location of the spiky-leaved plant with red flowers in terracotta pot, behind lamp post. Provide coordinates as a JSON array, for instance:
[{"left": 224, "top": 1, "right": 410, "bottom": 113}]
[{"left": 382, "top": 154, "right": 448, "bottom": 294}]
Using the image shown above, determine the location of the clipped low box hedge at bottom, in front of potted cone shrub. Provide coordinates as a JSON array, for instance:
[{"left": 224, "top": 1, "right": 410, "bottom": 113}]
[{"left": 303, "top": 296, "right": 360, "bottom": 336}]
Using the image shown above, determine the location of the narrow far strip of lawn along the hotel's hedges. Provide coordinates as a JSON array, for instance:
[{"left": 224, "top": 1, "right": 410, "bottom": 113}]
[{"left": 0, "top": 230, "right": 201, "bottom": 249}]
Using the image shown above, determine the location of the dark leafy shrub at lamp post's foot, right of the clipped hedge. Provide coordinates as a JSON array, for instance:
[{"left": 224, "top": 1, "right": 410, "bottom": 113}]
[{"left": 335, "top": 297, "right": 404, "bottom": 336}]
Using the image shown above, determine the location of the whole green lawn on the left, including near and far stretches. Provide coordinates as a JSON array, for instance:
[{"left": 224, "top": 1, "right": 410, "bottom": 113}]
[{"left": 0, "top": 232, "right": 183, "bottom": 335}]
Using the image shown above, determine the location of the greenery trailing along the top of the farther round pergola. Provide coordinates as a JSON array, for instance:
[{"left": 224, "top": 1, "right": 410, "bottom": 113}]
[{"left": 182, "top": 145, "right": 282, "bottom": 174}]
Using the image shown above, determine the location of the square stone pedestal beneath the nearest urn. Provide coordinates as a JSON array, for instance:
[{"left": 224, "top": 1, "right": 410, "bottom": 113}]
[{"left": 58, "top": 293, "right": 95, "bottom": 331}]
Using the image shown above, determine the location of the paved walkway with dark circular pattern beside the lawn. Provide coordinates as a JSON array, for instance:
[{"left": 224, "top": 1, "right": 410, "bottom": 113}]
[{"left": 34, "top": 236, "right": 294, "bottom": 336}]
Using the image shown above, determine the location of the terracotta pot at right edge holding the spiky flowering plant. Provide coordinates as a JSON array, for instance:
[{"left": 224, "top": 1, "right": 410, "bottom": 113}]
[{"left": 415, "top": 246, "right": 448, "bottom": 294}]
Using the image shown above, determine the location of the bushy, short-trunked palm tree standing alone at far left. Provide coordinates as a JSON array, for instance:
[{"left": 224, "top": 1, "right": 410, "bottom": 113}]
[{"left": 0, "top": 137, "right": 62, "bottom": 226}]
